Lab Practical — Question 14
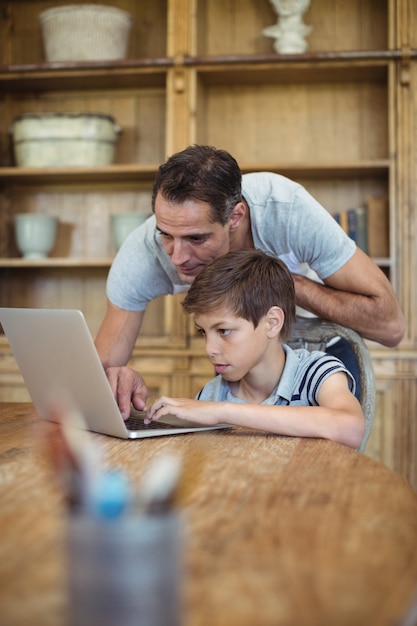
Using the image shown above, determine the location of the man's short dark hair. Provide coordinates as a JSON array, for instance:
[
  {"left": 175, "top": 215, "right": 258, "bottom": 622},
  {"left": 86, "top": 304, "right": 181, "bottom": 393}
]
[{"left": 152, "top": 145, "right": 242, "bottom": 225}]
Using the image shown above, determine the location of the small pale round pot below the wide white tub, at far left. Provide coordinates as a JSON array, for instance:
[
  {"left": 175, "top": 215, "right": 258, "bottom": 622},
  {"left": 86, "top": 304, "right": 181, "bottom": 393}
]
[{"left": 14, "top": 213, "right": 58, "bottom": 259}]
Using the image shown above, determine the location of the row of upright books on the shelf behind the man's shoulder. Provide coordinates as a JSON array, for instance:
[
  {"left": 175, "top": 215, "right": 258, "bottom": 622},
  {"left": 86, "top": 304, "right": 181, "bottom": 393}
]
[{"left": 333, "top": 196, "right": 389, "bottom": 258}]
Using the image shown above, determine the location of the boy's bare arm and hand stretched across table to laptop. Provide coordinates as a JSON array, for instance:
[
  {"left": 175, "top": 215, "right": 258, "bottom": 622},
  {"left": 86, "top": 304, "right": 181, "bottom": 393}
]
[{"left": 145, "top": 372, "right": 365, "bottom": 448}]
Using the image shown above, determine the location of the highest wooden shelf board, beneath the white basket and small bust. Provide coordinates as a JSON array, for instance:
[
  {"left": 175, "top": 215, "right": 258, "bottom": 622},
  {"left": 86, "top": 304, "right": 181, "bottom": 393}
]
[{"left": 0, "top": 50, "right": 400, "bottom": 92}]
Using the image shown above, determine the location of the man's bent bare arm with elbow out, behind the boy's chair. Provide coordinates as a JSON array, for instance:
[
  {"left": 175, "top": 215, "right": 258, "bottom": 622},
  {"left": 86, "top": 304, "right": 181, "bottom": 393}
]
[{"left": 293, "top": 248, "right": 405, "bottom": 348}]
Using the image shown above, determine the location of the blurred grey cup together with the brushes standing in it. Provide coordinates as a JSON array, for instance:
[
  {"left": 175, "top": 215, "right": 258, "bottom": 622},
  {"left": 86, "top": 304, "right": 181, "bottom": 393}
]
[{"left": 44, "top": 403, "right": 183, "bottom": 626}]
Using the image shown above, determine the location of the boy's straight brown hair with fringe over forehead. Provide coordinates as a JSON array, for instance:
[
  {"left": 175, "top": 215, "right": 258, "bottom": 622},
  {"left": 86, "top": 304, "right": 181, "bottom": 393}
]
[{"left": 182, "top": 249, "right": 295, "bottom": 341}]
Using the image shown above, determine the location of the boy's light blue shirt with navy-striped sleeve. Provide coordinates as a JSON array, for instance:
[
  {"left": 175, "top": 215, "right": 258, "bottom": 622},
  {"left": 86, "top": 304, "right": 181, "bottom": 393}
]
[{"left": 196, "top": 344, "right": 355, "bottom": 406}]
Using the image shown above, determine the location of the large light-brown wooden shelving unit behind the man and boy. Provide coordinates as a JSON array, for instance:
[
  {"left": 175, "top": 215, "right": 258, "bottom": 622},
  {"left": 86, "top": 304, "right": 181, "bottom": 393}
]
[{"left": 0, "top": 0, "right": 417, "bottom": 498}]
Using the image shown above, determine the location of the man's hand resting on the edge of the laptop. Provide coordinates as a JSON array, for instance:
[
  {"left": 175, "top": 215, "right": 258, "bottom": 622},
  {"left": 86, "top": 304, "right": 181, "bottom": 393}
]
[{"left": 106, "top": 366, "right": 149, "bottom": 420}]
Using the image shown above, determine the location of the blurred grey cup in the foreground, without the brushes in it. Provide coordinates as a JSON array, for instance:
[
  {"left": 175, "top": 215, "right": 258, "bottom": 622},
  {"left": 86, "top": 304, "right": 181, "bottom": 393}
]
[{"left": 68, "top": 512, "right": 182, "bottom": 626}]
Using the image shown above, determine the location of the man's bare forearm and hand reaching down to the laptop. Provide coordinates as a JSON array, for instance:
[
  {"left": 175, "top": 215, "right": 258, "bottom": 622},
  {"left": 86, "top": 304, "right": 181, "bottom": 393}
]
[{"left": 95, "top": 301, "right": 148, "bottom": 418}]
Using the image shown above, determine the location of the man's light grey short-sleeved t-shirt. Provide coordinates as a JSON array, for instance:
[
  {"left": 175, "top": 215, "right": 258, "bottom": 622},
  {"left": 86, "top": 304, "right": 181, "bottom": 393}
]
[{"left": 107, "top": 172, "right": 356, "bottom": 311}]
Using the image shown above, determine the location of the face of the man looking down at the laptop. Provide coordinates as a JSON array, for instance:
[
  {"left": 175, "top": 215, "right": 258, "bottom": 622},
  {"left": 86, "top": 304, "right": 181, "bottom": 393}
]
[{"left": 155, "top": 194, "right": 230, "bottom": 284}]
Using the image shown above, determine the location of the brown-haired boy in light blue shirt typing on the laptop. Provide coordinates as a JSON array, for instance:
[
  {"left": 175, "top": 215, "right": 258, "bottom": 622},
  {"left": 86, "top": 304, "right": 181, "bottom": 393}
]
[{"left": 148, "top": 249, "right": 365, "bottom": 448}]
